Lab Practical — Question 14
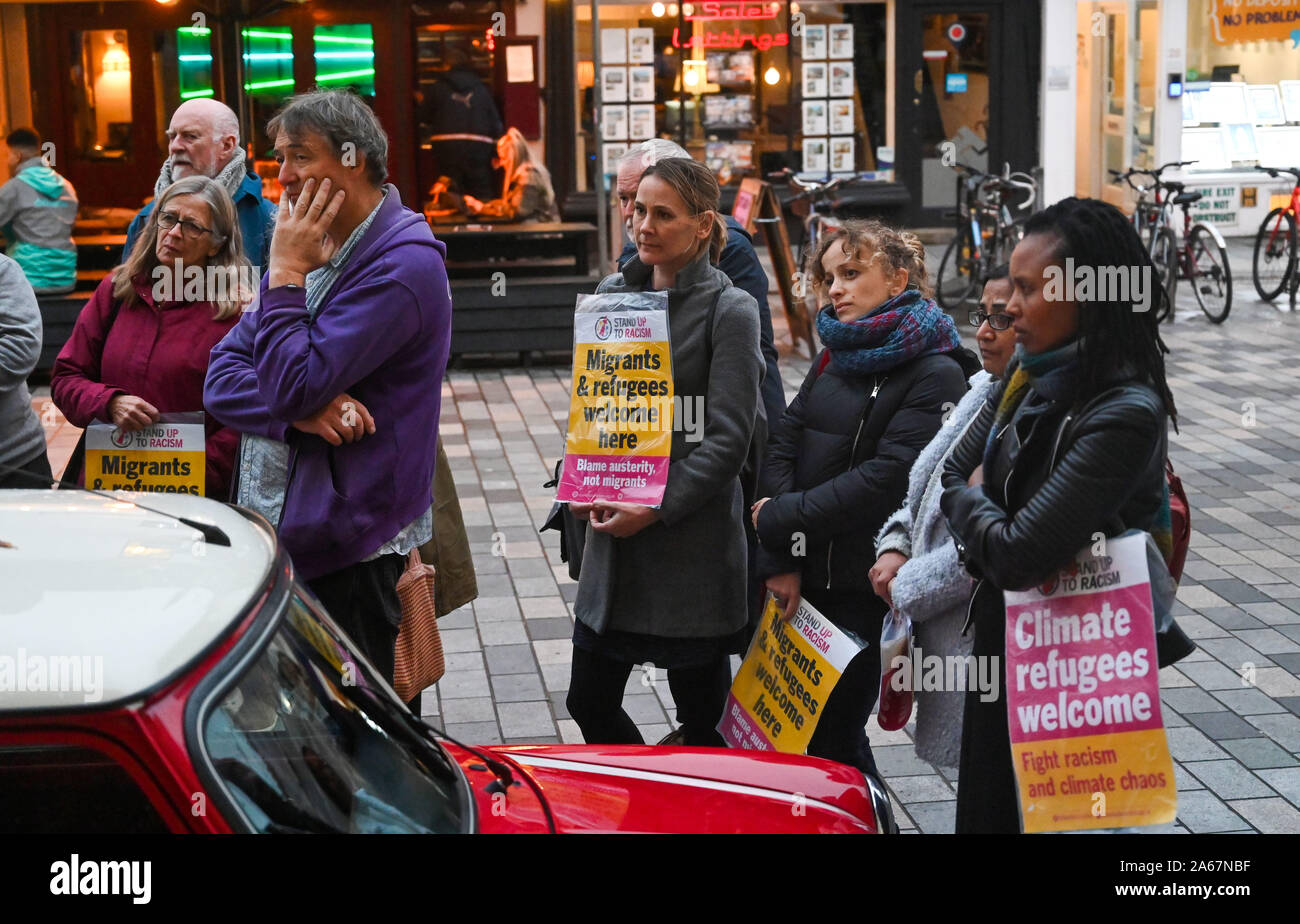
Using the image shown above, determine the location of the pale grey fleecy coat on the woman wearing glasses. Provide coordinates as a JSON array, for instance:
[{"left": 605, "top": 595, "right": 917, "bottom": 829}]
[{"left": 876, "top": 372, "right": 997, "bottom": 767}]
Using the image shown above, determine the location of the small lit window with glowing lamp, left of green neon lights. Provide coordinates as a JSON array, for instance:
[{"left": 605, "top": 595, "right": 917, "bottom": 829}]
[{"left": 73, "top": 29, "right": 133, "bottom": 160}]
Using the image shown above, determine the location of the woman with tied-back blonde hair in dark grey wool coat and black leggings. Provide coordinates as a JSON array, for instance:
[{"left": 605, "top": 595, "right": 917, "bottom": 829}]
[{"left": 567, "top": 157, "right": 763, "bottom": 746}]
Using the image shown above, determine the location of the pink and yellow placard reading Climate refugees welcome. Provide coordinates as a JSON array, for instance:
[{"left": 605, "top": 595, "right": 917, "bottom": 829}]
[{"left": 1005, "top": 533, "right": 1178, "bottom": 833}]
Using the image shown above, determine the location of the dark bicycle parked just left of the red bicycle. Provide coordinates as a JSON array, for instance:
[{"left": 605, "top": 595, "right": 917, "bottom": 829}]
[{"left": 1118, "top": 160, "right": 1232, "bottom": 324}]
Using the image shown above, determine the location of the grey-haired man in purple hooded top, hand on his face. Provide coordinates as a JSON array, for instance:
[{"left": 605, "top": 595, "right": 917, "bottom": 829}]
[{"left": 204, "top": 91, "right": 451, "bottom": 678}]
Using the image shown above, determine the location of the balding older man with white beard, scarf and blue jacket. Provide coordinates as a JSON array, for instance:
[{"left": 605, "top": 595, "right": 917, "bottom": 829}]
[{"left": 122, "top": 99, "right": 276, "bottom": 273}]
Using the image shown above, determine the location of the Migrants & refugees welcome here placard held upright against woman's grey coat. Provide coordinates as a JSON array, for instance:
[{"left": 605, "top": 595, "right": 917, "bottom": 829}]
[{"left": 556, "top": 292, "right": 673, "bottom": 507}]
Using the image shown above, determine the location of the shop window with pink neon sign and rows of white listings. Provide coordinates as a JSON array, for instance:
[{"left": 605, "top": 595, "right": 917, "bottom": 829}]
[{"left": 576, "top": 0, "right": 889, "bottom": 190}]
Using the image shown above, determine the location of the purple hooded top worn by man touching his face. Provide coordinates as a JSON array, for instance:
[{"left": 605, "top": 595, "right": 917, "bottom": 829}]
[{"left": 203, "top": 186, "right": 451, "bottom": 580}]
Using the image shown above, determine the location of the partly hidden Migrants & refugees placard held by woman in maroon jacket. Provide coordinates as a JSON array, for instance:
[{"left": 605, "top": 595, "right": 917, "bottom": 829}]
[{"left": 86, "top": 413, "right": 204, "bottom": 496}]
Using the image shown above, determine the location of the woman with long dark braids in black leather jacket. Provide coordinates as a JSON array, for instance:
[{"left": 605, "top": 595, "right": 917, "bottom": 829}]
[{"left": 941, "top": 199, "right": 1177, "bottom": 833}]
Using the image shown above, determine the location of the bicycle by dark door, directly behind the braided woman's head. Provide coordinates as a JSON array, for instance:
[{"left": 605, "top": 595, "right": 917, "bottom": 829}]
[{"left": 935, "top": 164, "right": 1039, "bottom": 311}]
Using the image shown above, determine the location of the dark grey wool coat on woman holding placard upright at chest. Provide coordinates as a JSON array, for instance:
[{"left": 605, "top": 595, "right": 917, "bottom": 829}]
[{"left": 573, "top": 251, "right": 763, "bottom": 638}]
